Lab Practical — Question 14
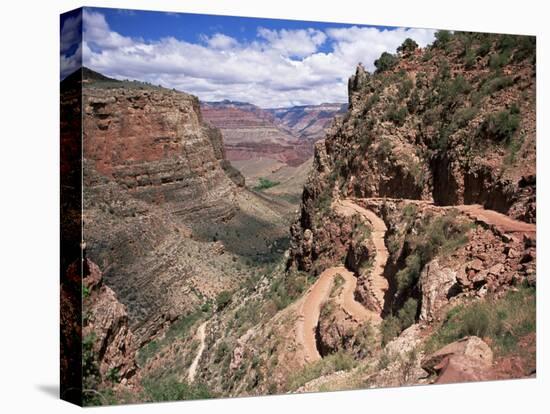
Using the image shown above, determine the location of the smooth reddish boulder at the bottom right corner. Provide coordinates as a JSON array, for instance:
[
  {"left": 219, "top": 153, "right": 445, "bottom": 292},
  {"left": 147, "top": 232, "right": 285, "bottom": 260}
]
[{"left": 422, "top": 336, "right": 493, "bottom": 384}]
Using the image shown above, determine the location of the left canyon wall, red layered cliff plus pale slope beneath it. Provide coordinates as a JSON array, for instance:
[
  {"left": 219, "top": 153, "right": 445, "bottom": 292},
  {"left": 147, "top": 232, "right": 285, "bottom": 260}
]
[{"left": 78, "top": 68, "right": 250, "bottom": 346}]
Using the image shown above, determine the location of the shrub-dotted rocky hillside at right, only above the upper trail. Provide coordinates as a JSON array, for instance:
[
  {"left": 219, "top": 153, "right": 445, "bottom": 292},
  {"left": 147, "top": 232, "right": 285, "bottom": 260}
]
[{"left": 293, "top": 34, "right": 536, "bottom": 278}]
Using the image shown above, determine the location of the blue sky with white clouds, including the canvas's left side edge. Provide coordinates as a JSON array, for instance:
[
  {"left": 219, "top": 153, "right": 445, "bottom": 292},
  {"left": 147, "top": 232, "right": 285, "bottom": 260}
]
[{"left": 60, "top": 8, "right": 435, "bottom": 108}]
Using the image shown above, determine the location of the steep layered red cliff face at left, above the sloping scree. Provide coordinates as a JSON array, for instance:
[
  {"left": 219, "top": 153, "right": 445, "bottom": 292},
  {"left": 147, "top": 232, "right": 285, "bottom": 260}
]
[{"left": 83, "top": 70, "right": 235, "bottom": 220}]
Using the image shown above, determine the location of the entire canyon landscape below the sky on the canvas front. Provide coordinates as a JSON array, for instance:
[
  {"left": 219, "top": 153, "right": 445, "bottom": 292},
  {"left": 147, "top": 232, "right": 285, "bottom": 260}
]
[{"left": 71, "top": 31, "right": 537, "bottom": 405}]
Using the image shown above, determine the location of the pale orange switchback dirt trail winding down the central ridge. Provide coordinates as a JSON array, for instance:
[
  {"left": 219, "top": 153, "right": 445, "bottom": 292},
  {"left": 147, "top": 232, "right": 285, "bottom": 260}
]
[{"left": 296, "top": 200, "right": 388, "bottom": 362}]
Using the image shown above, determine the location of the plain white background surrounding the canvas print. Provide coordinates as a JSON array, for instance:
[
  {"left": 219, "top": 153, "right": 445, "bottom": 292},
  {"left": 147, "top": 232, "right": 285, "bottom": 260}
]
[{"left": 0, "top": 0, "right": 550, "bottom": 414}]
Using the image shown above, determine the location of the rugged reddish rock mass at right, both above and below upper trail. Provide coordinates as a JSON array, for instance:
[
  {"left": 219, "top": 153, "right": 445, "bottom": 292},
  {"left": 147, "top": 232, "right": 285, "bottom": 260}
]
[{"left": 289, "top": 33, "right": 536, "bottom": 340}]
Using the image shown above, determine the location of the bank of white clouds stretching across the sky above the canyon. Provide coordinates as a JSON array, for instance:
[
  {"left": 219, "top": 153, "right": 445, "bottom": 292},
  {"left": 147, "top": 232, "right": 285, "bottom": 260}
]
[{"left": 83, "top": 11, "right": 434, "bottom": 107}]
